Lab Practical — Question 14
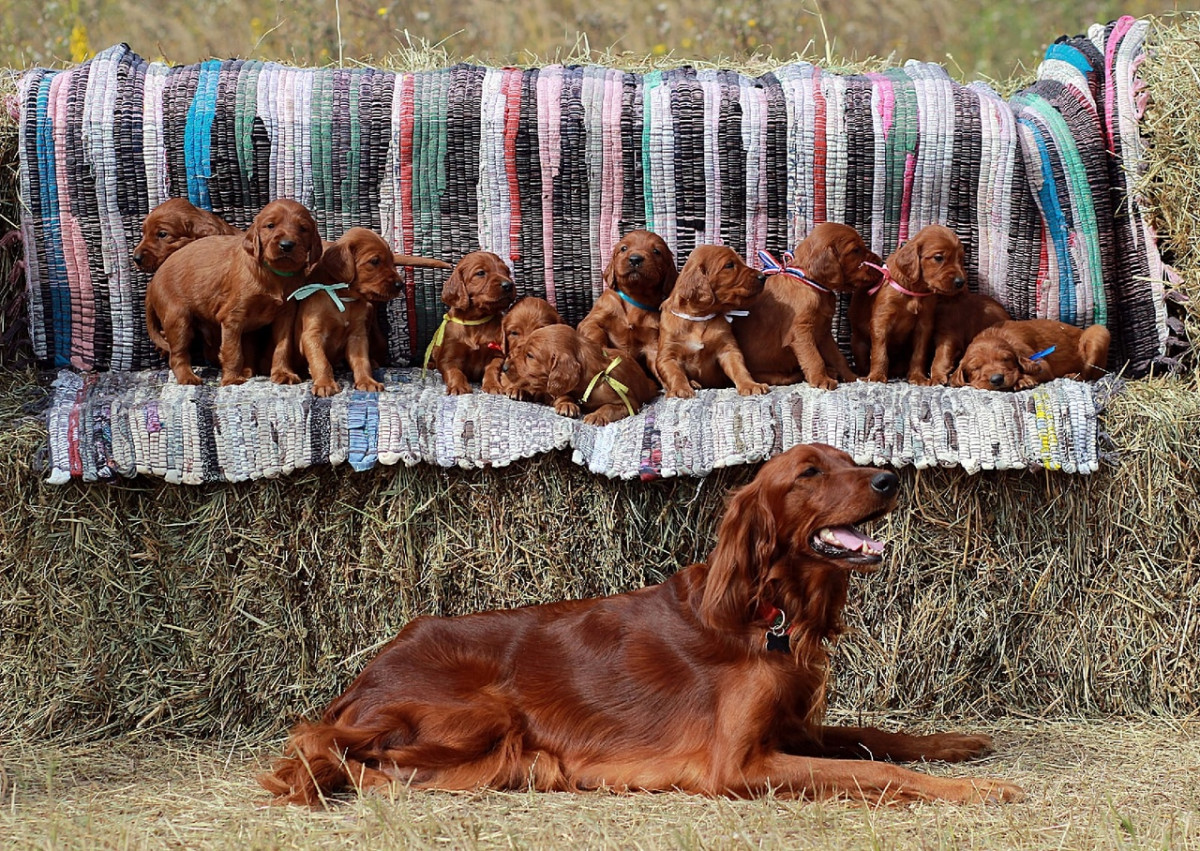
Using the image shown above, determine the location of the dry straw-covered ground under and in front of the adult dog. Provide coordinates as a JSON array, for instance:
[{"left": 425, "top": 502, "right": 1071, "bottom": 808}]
[{"left": 0, "top": 719, "right": 1200, "bottom": 851}]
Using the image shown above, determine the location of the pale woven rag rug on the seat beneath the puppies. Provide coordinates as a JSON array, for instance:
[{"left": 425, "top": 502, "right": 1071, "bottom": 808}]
[{"left": 49, "top": 368, "right": 1112, "bottom": 484}]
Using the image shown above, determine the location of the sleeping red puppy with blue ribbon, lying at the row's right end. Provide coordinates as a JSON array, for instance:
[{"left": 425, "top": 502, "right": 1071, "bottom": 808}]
[{"left": 950, "top": 319, "right": 1112, "bottom": 390}]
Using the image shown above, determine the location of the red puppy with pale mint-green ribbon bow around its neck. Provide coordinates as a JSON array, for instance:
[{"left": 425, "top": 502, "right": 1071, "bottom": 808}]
[{"left": 271, "top": 228, "right": 452, "bottom": 396}]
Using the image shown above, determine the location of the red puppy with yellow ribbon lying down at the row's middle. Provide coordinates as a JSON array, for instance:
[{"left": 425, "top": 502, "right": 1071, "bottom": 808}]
[{"left": 500, "top": 325, "right": 659, "bottom": 425}]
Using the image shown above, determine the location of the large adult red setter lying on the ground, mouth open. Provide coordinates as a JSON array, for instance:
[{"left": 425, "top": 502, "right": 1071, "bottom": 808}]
[{"left": 259, "top": 445, "right": 1021, "bottom": 804}]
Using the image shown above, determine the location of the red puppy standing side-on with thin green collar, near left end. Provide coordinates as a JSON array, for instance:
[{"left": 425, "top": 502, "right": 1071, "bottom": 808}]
[{"left": 146, "top": 199, "right": 322, "bottom": 384}]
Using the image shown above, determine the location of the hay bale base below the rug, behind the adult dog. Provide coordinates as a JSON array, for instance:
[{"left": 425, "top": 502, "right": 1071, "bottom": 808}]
[{"left": 0, "top": 369, "right": 1200, "bottom": 735}]
